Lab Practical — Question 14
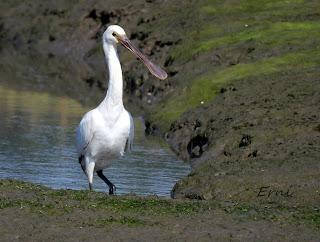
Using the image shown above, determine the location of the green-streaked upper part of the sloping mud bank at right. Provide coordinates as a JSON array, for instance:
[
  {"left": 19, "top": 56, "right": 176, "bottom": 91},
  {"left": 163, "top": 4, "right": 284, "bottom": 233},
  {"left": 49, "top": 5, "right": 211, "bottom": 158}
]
[{"left": 150, "top": 0, "right": 320, "bottom": 131}]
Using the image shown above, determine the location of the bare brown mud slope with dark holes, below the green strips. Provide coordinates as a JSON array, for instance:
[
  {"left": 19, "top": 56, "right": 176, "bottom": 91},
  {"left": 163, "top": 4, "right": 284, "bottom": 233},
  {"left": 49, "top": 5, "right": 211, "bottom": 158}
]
[{"left": 167, "top": 69, "right": 320, "bottom": 205}]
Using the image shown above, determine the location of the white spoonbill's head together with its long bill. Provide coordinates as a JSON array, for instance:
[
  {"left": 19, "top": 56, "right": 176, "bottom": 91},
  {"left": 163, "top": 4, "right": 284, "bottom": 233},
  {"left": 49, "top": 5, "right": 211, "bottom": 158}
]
[{"left": 103, "top": 25, "right": 168, "bottom": 80}]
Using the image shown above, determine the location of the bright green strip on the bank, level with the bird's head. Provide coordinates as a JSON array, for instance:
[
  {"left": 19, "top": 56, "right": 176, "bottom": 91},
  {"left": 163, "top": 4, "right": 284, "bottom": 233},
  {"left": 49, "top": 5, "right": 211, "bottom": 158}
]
[{"left": 174, "top": 21, "right": 320, "bottom": 60}]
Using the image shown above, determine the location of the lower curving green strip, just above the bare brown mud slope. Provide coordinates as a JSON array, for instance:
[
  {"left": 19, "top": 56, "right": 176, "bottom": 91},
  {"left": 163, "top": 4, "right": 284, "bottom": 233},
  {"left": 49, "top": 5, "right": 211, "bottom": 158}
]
[{"left": 153, "top": 49, "right": 320, "bottom": 129}]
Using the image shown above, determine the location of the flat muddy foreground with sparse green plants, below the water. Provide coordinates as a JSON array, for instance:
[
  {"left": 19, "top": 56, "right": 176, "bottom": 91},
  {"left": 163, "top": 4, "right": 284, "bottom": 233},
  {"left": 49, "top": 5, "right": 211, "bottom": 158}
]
[{"left": 0, "top": 180, "right": 320, "bottom": 241}]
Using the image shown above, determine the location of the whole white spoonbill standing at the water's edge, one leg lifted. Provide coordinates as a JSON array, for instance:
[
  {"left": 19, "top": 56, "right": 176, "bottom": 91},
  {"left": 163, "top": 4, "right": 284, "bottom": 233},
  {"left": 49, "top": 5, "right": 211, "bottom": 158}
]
[{"left": 76, "top": 25, "right": 167, "bottom": 194}]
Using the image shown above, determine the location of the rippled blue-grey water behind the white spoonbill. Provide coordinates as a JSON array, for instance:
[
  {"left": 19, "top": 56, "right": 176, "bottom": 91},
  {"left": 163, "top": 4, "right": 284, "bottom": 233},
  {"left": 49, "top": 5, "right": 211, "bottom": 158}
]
[{"left": 0, "top": 86, "right": 190, "bottom": 196}]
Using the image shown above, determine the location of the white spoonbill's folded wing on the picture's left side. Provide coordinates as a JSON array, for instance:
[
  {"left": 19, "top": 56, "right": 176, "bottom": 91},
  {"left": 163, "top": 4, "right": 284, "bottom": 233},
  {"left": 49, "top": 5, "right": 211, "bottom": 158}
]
[{"left": 76, "top": 111, "right": 94, "bottom": 157}]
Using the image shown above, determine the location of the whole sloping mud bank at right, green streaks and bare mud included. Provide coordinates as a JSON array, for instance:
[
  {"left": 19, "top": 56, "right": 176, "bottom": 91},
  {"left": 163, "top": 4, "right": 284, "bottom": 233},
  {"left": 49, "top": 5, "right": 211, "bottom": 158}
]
[{"left": 139, "top": 1, "right": 320, "bottom": 206}]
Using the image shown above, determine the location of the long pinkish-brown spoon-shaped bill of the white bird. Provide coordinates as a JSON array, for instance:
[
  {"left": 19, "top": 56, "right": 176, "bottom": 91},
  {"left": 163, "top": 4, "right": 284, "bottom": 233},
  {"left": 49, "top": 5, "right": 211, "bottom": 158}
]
[{"left": 117, "top": 36, "right": 168, "bottom": 80}]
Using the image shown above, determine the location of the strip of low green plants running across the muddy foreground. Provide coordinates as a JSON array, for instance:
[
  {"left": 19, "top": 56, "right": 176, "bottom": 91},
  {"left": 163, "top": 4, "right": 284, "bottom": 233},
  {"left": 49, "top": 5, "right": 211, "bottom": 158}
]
[{"left": 0, "top": 180, "right": 320, "bottom": 230}]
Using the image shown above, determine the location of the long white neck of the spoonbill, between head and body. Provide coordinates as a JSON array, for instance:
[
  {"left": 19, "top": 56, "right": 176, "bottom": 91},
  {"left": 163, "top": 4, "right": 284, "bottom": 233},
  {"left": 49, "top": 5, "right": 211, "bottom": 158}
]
[{"left": 103, "top": 43, "right": 123, "bottom": 108}]
